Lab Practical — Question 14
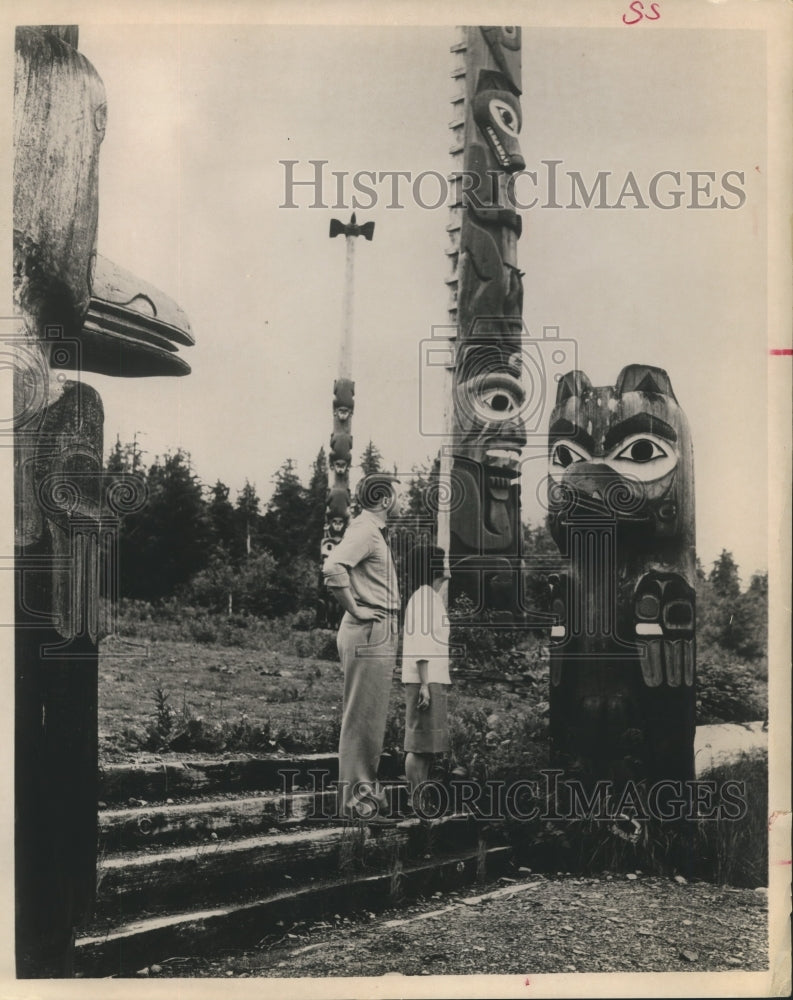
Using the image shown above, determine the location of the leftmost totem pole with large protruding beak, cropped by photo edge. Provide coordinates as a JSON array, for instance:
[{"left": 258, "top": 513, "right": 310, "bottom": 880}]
[{"left": 10, "top": 27, "right": 193, "bottom": 978}]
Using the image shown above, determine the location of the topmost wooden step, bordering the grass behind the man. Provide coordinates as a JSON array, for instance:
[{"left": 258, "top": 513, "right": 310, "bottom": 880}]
[{"left": 99, "top": 753, "right": 402, "bottom": 803}]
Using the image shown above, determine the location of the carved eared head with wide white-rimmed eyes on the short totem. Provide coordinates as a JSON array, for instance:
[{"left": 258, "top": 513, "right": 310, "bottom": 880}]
[{"left": 548, "top": 365, "right": 693, "bottom": 541}]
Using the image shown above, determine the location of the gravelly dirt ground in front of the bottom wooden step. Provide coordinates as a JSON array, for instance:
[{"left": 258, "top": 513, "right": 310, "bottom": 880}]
[{"left": 138, "top": 874, "right": 768, "bottom": 977}]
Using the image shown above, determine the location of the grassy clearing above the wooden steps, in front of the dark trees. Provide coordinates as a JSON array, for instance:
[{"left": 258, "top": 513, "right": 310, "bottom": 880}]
[{"left": 99, "top": 616, "right": 518, "bottom": 759}]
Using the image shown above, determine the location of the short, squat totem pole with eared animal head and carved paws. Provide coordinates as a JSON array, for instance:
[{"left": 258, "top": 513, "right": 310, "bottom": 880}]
[{"left": 548, "top": 365, "right": 696, "bottom": 782}]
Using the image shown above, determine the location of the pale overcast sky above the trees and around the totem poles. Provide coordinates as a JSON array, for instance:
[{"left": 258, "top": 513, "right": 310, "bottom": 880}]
[{"left": 80, "top": 24, "right": 768, "bottom": 583}]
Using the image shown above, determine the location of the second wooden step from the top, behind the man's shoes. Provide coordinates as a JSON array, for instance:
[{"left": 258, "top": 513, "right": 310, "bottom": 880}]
[{"left": 99, "top": 782, "right": 407, "bottom": 852}]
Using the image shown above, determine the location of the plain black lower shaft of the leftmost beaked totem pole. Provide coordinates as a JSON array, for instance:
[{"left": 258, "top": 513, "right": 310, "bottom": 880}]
[{"left": 14, "top": 619, "right": 98, "bottom": 979}]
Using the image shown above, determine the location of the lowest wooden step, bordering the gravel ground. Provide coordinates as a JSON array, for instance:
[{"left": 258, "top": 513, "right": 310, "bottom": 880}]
[{"left": 75, "top": 842, "right": 512, "bottom": 977}]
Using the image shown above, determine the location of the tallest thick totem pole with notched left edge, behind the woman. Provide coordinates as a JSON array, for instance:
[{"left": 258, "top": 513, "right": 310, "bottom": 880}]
[{"left": 446, "top": 27, "right": 526, "bottom": 614}]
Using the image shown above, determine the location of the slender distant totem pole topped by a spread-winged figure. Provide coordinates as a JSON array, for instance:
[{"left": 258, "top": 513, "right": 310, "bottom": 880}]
[{"left": 318, "top": 213, "right": 374, "bottom": 626}]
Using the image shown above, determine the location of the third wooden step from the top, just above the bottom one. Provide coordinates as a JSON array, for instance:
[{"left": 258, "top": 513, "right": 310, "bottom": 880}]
[{"left": 96, "top": 816, "right": 476, "bottom": 917}]
